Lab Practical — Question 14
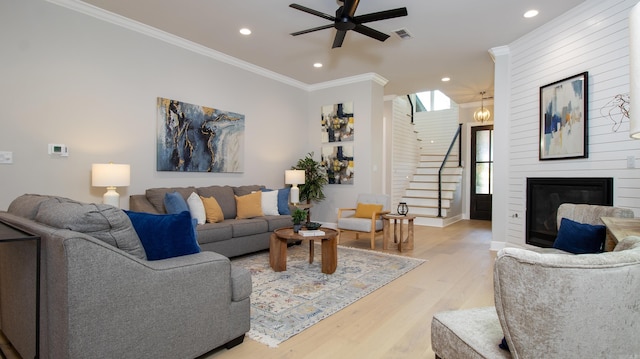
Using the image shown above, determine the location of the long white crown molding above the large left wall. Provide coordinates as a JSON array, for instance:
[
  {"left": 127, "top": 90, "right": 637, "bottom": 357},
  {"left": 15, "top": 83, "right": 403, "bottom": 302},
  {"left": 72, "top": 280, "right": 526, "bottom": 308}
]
[{"left": 46, "top": 0, "right": 310, "bottom": 91}]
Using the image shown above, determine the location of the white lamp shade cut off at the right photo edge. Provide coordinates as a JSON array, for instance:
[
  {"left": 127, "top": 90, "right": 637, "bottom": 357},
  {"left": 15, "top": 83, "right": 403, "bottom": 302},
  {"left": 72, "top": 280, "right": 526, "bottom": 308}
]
[{"left": 629, "top": 4, "right": 640, "bottom": 139}]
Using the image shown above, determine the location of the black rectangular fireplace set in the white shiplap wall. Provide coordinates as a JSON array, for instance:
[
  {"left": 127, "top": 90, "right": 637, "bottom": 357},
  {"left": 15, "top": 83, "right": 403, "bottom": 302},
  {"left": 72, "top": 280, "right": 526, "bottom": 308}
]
[{"left": 526, "top": 177, "right": 613, "bottom": 247}]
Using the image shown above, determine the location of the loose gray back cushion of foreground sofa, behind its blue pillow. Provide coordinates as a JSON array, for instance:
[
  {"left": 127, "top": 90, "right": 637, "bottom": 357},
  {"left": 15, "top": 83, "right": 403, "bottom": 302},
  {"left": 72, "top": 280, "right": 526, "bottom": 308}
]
[{"left": 35, "top": 197, "right": 146, "bottom": 259}]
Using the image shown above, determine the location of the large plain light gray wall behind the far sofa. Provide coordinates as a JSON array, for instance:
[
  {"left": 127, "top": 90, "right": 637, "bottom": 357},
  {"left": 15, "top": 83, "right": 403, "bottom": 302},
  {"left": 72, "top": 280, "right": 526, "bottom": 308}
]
[{"left": 0, "top": 0, "right": 310, "bottom": 209}]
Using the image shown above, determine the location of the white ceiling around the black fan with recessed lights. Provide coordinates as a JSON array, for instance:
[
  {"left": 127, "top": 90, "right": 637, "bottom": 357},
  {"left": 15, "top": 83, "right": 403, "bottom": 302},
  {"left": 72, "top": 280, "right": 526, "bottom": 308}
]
[{"left": 79, "top": 0, "right": 584, "bottom": 104}]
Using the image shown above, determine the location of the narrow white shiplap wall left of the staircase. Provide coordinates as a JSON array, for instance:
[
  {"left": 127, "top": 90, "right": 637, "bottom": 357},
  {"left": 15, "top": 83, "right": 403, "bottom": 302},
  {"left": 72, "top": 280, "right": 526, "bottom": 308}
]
[{"left": 391, "top": 97, "right": 420, "bottom": 210}]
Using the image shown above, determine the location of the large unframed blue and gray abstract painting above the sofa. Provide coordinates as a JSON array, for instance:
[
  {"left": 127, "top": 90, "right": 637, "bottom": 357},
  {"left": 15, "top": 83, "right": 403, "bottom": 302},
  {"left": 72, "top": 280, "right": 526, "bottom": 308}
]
[{"left": 157, "top": 97, "right": 244, "bottom": 172}]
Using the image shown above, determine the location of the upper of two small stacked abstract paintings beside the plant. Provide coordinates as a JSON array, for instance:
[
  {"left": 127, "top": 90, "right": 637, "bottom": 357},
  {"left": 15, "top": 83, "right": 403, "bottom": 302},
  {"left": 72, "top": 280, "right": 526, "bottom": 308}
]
[{"left": 320, "top": 102, "right": 353, "bottom": 143}]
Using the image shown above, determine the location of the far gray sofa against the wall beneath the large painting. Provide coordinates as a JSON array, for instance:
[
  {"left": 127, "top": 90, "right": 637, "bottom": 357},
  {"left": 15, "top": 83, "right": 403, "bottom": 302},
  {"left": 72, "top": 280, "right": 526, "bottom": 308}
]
[{"left": 129, "top": 185, "right": 293, "bottom": 258}]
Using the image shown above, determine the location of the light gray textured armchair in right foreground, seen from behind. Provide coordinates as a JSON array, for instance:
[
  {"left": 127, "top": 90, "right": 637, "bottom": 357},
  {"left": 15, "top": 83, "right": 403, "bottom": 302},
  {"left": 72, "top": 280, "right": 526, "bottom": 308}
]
[{"left": 431, "top": 237, "right": 640, "bottom": 359}]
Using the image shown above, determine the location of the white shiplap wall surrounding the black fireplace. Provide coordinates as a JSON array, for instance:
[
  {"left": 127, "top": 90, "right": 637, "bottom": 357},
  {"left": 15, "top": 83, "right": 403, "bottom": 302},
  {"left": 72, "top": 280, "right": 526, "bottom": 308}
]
[{"left": 506, "top": 0, "right": 640, "bottom": 245}]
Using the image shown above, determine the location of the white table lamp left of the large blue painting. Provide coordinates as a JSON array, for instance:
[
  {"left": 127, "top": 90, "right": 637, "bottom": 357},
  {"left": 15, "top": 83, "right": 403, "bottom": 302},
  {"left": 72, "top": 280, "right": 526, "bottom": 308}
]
[{"left": 91, "top": 163, "right": 131, "bottom": 208}]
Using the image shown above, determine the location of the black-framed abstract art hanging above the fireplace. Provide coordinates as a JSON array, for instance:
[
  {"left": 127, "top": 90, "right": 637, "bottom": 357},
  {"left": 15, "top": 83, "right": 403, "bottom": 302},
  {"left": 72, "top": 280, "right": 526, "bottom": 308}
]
[{"left": 539, "top": 72, "right": 589, "bottom": 160}]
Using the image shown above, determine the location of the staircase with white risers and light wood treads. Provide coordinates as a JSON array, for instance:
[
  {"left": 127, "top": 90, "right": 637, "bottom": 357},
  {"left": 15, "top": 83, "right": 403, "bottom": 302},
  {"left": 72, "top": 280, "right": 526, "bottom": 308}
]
[{"left": 401, "top": 154, "right": 463, "bottom": 227}]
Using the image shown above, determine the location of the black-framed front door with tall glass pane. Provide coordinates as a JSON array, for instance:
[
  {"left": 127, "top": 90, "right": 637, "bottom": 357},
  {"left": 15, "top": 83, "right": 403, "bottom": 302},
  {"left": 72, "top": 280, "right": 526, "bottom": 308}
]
[{"left": 469, "top": 125, "right": 493, "bottom": 220}]
